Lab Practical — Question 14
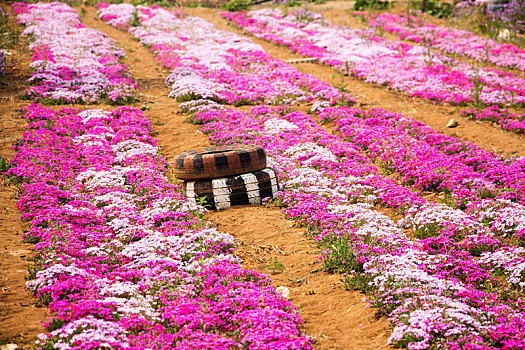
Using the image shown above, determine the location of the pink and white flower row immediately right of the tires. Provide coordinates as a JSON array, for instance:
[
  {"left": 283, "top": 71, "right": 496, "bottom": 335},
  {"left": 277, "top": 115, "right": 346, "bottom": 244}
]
[{"left": 196, "top": 106, "right": 525, "bottom": 349}]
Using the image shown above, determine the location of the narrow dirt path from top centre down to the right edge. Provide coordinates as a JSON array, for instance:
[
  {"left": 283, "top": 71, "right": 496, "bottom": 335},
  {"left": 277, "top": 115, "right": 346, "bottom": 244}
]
[{"left": 185, "top": 8, "right": 525, "bottom": 156}]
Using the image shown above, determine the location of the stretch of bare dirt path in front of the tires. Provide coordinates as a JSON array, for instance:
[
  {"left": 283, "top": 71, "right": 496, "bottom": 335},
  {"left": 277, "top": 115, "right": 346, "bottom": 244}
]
[{"left": 208, "top": 206, "right": 390, "bottom": 350}]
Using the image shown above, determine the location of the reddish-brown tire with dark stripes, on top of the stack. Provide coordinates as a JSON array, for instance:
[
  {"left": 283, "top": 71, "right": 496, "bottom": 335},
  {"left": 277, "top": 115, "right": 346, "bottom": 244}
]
[{"left": 173, "top": 145, "right": 266, "bottom": 181}]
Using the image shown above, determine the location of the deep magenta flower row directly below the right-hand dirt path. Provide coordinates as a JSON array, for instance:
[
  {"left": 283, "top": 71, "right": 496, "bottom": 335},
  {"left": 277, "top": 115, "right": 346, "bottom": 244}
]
[{"left": 319, "top": 107, "right": 525, "bottom": 206}]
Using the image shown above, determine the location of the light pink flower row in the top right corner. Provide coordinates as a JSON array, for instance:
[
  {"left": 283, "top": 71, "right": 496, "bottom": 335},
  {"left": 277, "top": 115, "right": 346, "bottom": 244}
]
[{"left": 365, "top": 13, "right": 525, "bottom": 71}]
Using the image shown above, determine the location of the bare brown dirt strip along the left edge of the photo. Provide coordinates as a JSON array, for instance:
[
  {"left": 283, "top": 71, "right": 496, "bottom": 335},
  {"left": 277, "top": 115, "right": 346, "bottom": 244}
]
[{"left": 0, "top": 5, "right": 48, "bottom": 347}]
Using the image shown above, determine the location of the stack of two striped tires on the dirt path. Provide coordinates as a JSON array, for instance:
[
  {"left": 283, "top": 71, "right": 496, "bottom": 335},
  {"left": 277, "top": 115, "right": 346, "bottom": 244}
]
[{"left": 173, "top": 145, "right": 279, "bottom": 209}]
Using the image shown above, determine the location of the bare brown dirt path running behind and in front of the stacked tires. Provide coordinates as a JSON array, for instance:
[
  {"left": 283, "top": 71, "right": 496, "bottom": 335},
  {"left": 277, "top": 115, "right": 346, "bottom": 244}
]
[{"left": 82, "top": 7, "right": 390, "bottom": 349}]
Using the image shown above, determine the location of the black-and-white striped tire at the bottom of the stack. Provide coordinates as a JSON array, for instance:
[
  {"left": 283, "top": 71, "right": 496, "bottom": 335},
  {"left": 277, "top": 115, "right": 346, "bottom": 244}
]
[{"left": 182, "top": 168, "right": 279, "bottom": 210}]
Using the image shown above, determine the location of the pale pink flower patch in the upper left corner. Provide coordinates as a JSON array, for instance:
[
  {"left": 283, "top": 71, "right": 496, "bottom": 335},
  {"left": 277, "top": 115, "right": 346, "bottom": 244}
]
[{"left": 13, "top": 2, "right": 137, "bottom": 104}]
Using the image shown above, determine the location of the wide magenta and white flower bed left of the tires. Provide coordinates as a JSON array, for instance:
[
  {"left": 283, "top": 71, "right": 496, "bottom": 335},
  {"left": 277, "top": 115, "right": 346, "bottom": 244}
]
[{"left": 9, "top": 105, "right": 310, "bottom": 349}]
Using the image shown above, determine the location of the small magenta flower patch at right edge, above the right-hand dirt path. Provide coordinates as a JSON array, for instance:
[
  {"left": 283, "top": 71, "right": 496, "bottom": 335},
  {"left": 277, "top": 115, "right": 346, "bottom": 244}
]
[{"left": 461, "top": 106, "right": 525, "bottom": 134}]
